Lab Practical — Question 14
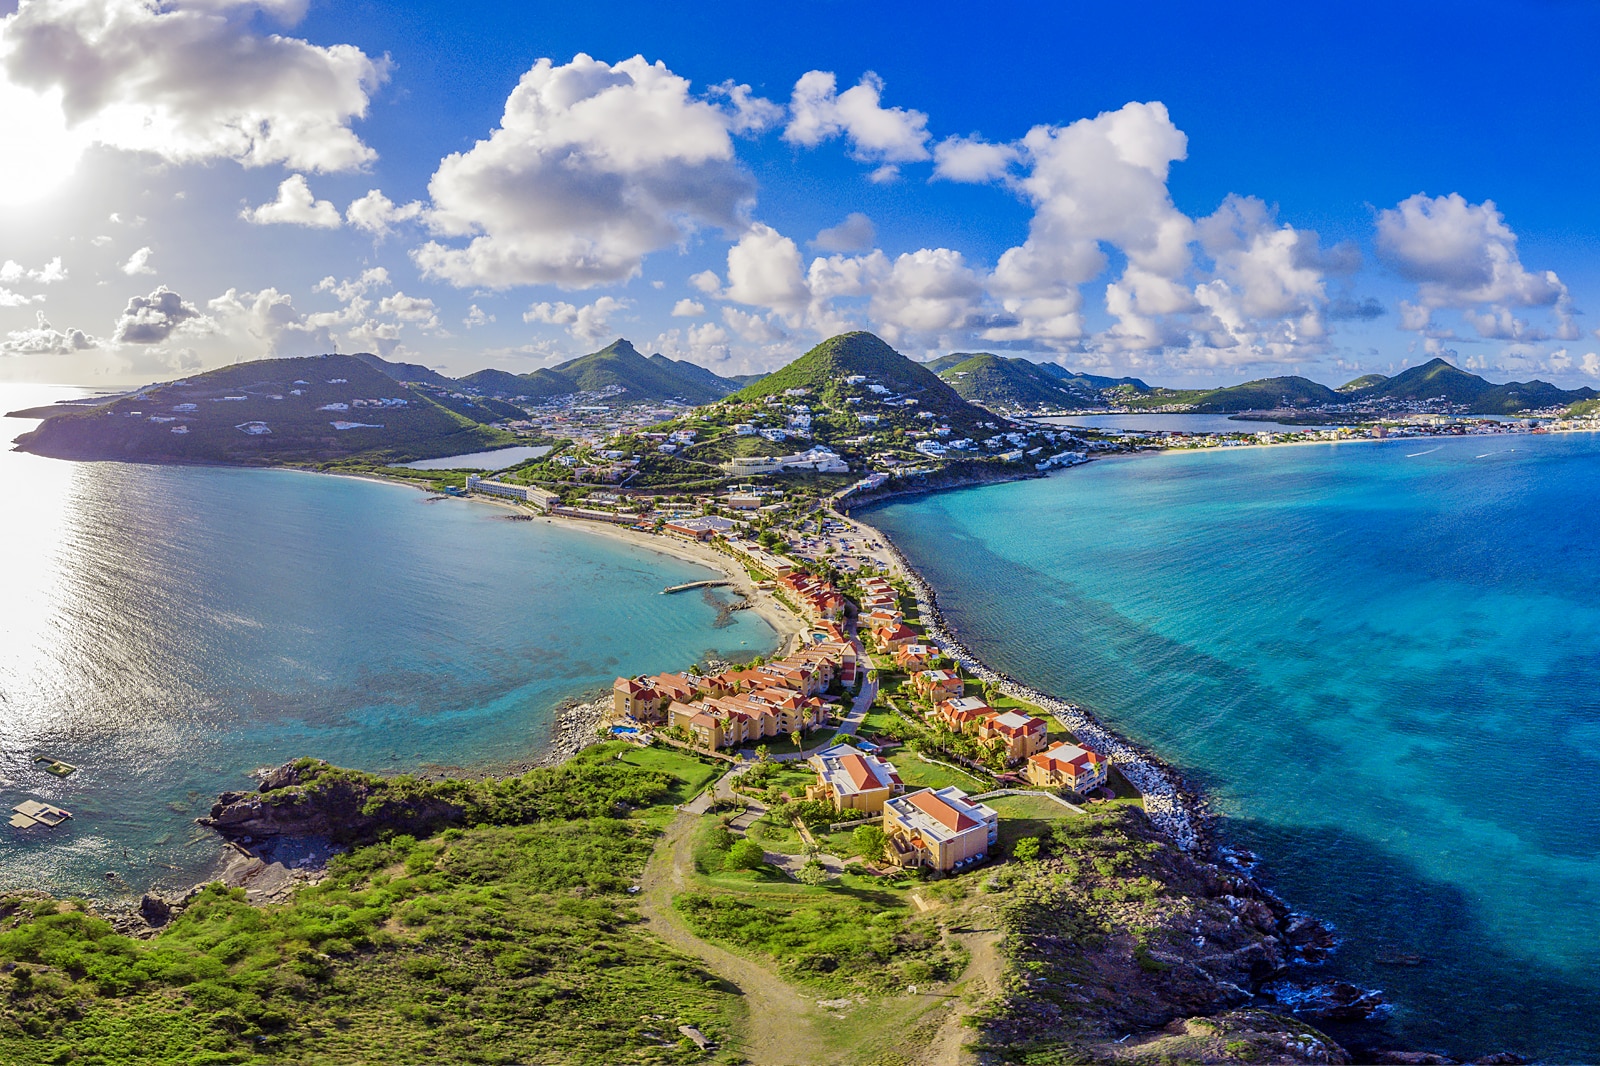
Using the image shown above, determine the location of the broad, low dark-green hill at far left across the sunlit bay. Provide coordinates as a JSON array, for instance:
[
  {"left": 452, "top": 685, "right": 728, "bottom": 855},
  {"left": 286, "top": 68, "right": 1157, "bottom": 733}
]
[{"left": 16, "top": 355, "right": 515, "bottom": 463}]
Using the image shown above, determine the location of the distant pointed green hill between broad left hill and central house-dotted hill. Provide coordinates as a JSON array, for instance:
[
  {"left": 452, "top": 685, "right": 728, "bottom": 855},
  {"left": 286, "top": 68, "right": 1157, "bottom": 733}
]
[{"left": 458, "top": 339, "right": 734, "bottom": 405}]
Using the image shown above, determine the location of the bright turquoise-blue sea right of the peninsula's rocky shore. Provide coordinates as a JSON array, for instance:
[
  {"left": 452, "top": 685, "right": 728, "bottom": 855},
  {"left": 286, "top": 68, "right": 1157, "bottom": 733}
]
[{"left": 866, "top": 435, "right": 1600, "bottom": 1063}]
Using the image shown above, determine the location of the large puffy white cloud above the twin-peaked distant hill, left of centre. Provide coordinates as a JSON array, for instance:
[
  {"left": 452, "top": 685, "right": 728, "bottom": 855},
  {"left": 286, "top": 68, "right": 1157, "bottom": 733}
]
[{"left": 413, "top": 54, "right": 755, "bottom": 288}]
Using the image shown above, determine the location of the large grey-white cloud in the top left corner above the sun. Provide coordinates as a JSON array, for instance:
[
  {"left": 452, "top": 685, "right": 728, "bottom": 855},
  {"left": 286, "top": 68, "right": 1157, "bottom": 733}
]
[{"left": 0, "top": 0, "right": 387, "bottom": 171}]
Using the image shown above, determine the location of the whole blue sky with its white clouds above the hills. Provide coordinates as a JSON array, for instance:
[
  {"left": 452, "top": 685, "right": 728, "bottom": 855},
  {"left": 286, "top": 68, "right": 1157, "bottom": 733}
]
[{"left": 0, "top": 0, "right": 1600, "bottom": 384}]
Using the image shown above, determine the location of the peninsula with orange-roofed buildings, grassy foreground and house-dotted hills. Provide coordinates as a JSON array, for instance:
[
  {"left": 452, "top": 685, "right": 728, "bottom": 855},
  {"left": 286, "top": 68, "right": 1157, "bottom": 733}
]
[{"left": 0, "top": 335, "right": 1536, "bottom": 1063}]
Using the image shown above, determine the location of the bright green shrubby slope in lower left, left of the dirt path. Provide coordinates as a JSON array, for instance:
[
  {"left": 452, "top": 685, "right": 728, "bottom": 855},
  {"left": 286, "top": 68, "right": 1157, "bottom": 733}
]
[{"left": 0, "top": 746, "right": 738, "bottom": 1066}]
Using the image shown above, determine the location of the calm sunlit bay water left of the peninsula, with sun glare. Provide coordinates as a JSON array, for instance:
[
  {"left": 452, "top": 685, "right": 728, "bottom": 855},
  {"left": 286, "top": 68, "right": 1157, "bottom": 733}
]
[{"left": 0, "top": 386, "right": 776, "bottom": 898}]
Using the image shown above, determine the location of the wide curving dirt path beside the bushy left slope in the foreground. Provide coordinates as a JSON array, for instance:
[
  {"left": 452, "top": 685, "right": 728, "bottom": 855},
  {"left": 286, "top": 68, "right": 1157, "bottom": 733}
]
[{"left": 638, "top": 813, "right": 829, "bottom": 1066}]
